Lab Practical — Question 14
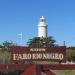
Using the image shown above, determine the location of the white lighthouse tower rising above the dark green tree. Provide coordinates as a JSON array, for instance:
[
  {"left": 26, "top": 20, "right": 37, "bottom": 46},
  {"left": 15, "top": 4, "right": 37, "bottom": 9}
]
[{"left": 38, "top": 16, "right": 47, "bottom": 37}]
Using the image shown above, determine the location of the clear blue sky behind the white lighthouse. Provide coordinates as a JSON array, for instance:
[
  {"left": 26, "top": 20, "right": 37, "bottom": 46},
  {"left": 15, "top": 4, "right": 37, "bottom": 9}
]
[{"left": 0, "top": 0, "right": 75, "bottom": 46}]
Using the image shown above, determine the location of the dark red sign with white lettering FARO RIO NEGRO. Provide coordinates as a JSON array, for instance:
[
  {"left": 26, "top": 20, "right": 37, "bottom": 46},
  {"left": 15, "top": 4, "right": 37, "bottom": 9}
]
[{"left": 10, "top": 46, "right": 66, "bottom": 62}]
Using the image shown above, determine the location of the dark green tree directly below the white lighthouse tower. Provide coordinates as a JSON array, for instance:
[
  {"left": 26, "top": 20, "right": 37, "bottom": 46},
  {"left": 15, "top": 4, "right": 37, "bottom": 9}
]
[{"left": 28, "top": 36, "right": 55, "bottom": 47}]
